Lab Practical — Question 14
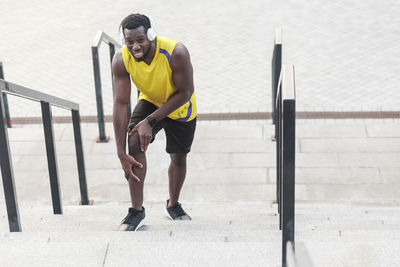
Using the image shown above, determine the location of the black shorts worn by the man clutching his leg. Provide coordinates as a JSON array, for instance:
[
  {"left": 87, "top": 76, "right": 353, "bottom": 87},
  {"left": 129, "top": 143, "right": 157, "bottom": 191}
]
[{"left": 128, "top": 99, "right": 197, "bottom": 154}]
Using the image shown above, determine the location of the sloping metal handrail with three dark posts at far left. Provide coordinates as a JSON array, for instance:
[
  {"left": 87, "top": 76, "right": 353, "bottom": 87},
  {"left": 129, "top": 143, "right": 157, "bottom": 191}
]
[{"left": 0, "top": 79, "right": 89, "bottom": 232}]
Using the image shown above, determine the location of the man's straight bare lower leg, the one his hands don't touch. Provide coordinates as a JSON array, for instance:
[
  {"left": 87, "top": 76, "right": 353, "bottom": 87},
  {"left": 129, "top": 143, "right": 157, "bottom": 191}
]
[{"left": 168, "top": 154, "right": 187, "bottom": 207}]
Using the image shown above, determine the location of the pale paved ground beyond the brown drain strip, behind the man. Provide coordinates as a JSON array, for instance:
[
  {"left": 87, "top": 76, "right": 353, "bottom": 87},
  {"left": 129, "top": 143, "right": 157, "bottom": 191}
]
[{"left": 0, "top": 0, "right": 400, "bottom": 117}]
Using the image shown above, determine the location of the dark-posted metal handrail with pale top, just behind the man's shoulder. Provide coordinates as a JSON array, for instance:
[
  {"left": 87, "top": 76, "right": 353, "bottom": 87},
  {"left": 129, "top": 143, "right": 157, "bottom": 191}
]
[{"left": 92, "top": 31, "right": 123, "bottom": 142}]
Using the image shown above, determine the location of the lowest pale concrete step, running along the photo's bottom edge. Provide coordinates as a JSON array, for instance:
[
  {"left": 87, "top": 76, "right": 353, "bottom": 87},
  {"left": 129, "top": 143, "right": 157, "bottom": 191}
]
[{"left": 0, "top": 229, "right": 400, "bottom": 266}]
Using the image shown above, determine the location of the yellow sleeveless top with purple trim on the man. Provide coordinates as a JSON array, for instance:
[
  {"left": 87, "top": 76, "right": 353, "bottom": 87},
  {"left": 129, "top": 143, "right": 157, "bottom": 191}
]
[{"left": 121, "top": 36, "right": 197, "bottom": 121}]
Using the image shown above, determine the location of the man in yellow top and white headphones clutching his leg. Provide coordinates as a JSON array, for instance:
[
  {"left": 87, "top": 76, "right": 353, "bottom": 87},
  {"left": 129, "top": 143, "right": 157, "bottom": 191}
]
[{"left": 112, "top": 14, "right": 197, "bottom": 231}]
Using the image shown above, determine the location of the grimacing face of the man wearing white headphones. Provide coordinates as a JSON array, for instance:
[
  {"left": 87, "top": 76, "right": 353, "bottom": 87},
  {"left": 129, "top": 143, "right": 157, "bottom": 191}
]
[{"left": 124, "top": 26, "right": 151, "bottom": 61}]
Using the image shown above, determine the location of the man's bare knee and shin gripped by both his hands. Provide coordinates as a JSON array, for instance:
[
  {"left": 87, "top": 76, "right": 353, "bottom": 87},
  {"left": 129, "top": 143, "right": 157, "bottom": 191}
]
[{"left": 128, "top": 132, "right": 147, "bottom": 210}]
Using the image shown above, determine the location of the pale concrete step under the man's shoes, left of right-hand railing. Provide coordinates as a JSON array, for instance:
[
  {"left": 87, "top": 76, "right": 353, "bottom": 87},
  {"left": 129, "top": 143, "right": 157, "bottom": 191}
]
[{"left": 0, "top": 202, "right": 278, "bottom": 231}]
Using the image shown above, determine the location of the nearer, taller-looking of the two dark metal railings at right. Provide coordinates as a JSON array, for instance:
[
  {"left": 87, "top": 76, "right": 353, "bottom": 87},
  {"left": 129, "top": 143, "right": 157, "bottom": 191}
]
[{"left": 276, "top": 65, "right": 296, "bottom": 267}]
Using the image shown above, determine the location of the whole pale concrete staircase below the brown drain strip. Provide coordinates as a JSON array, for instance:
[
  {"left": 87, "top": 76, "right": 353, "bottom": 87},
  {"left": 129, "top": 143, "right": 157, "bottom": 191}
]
[{"left": 0, "top": 121, "right": 400, "bottom": 267}]
